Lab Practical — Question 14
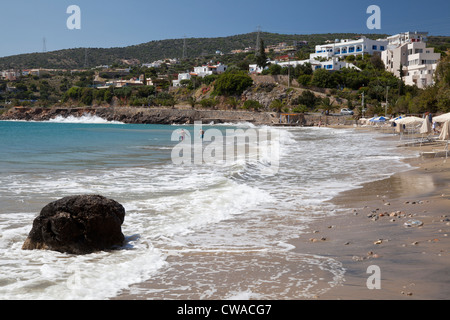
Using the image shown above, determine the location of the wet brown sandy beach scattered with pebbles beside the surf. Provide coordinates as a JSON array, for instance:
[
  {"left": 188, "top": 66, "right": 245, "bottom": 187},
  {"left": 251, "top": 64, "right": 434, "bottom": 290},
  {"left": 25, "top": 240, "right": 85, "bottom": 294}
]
[{"left": 293, "top": 138, "right": 450, "bottom": 300}]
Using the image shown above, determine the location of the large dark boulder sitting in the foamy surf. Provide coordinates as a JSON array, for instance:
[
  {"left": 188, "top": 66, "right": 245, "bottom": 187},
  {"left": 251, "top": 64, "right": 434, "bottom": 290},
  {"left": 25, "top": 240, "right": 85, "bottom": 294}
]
[{"left": 22, "top": 195, "right": 125, "bottom": 254}]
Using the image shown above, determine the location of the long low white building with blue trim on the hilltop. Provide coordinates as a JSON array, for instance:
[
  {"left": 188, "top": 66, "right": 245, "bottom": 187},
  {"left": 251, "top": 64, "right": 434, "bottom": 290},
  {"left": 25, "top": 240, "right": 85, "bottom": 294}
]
[{"left": 310, "top": 37, "right": 388, "bottom": 59}]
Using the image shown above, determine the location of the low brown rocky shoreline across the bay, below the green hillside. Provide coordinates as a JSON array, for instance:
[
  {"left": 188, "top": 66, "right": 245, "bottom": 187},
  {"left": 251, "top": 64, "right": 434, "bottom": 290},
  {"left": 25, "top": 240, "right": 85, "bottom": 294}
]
[{"left": 0, "top": 106, "right": 357, "bottom": 127}]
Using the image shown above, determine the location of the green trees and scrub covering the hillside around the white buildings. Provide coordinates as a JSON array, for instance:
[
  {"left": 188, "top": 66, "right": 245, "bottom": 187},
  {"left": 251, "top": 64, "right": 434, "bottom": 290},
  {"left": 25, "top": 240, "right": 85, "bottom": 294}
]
[{"left": 0, "top": 33, "right": 450, "bottom": 115}]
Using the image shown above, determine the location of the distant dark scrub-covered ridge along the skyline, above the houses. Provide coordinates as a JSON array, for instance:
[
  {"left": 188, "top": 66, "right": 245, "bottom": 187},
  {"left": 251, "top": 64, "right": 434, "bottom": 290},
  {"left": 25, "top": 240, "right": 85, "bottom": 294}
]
[{"left": 0, "top": 32, "right": 390, "bottom": 70}]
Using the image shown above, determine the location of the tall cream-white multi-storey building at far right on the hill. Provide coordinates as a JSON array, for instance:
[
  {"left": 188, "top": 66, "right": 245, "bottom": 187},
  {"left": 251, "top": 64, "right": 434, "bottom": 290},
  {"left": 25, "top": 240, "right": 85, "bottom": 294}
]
[{"left": 381, "top": 32, "right": 441, "bottom": 88}]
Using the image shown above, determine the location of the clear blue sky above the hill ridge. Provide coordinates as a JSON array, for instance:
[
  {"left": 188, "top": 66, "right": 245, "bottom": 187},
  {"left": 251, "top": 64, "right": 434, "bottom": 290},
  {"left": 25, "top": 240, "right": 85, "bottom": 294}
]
[{"left": 0, "top": 0, "right": 450, "bottom": 57}]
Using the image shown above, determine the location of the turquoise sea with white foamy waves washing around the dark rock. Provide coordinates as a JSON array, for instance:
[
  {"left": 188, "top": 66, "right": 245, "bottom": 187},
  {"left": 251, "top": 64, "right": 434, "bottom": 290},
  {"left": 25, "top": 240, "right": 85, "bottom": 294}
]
[{"left": 0, "top": 115, "right": 410, "bottom": 300}]
